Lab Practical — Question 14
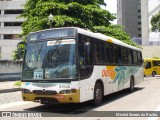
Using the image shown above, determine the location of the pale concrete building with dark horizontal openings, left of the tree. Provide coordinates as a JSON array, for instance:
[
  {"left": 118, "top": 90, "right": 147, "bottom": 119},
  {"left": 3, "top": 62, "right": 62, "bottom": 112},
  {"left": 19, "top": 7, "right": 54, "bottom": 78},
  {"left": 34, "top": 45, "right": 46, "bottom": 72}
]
[{"left": 0, "top": 0, "right": 25, "bottom": 60}]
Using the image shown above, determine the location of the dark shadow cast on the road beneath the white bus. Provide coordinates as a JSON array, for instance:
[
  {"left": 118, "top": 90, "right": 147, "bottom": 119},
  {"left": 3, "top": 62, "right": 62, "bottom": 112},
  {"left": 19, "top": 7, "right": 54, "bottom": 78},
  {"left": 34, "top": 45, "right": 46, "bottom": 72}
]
[{"left": 24, "top": 87, "right": 144, "bottom": 117}]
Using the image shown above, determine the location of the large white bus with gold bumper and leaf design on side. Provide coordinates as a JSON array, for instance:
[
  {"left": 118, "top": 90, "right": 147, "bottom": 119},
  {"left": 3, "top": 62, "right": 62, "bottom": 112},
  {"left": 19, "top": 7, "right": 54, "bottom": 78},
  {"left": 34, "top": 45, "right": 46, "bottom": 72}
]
[{"left": 18, "top": 27, "right": 144, "bottom": 106}]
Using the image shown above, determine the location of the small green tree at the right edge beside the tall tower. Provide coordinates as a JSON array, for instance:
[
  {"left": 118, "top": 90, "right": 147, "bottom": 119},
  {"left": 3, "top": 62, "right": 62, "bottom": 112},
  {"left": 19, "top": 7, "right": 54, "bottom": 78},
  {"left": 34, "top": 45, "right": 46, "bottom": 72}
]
[{"left": 151, "top": 11, "right": 160, "bottom": 32}]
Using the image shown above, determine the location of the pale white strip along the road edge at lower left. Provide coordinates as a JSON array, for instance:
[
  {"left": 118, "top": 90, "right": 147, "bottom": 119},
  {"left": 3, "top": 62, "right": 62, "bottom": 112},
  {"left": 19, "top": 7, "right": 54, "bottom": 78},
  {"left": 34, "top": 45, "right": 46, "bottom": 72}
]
[{"left": 0, "top": 101, "right": 33, "bottom": 110}]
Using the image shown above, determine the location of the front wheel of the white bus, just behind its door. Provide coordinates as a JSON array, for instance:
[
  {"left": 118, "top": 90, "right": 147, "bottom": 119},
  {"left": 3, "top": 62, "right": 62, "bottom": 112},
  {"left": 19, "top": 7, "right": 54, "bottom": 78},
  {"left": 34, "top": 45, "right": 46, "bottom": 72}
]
[{"left": 92, "top": 82, "right": 103, "bottom": 106}]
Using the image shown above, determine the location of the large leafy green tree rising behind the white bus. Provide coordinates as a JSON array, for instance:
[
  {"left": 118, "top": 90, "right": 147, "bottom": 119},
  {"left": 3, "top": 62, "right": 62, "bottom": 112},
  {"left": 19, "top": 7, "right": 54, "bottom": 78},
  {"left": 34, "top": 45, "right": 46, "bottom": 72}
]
[{"left": 14, "top": 0, "right": 138, "bottom": 59}]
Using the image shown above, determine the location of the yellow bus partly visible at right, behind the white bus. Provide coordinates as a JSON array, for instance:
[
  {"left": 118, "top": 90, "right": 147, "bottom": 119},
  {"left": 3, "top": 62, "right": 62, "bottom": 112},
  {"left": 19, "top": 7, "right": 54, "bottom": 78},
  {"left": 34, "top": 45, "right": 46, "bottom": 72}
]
[{"left": 144, "top": 58, "right": 160, "bottom": 77}]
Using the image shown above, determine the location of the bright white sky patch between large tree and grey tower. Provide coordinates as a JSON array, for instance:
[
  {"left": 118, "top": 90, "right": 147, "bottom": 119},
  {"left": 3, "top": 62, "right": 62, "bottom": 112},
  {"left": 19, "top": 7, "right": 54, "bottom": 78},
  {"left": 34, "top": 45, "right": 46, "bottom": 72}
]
[{"left": 102, "top": 0, "right": 117, "bottom": 24}]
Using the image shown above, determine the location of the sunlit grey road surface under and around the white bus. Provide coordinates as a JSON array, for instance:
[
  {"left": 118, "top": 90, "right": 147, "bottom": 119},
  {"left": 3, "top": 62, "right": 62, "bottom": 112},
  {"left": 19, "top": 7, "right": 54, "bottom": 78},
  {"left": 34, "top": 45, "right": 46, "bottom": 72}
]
[{"left": 0, "top": 76, "right": 160, "bottom": 120}]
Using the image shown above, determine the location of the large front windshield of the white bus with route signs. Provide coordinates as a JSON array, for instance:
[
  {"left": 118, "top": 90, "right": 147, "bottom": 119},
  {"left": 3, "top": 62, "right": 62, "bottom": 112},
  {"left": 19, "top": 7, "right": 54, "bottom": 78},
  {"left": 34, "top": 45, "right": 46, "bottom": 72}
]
[{"left": 22, "top": 39, "right": 77, "bottom": 80}]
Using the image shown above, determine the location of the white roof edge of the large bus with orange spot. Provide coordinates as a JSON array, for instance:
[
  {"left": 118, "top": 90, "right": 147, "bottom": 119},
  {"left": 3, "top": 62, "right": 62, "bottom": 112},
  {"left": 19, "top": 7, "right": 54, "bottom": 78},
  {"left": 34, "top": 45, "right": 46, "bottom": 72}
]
[{"left": 29, "top": 27, "right": 141, "bottom": 51}]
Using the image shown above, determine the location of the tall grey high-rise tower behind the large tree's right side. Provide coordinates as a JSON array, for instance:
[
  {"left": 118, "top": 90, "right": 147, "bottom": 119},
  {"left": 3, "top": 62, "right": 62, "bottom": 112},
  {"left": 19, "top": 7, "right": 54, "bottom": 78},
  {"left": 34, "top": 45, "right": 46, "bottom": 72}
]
[{"left": 117, "top": 0, "right": 142, "bottom": 43}]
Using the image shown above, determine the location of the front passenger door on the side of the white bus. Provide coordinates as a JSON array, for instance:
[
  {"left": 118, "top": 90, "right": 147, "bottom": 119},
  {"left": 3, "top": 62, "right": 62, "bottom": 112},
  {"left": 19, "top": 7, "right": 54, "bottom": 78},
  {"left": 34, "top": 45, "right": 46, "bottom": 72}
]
[{"left": 78, "top": 34, "right": 93, "bottom": 102}]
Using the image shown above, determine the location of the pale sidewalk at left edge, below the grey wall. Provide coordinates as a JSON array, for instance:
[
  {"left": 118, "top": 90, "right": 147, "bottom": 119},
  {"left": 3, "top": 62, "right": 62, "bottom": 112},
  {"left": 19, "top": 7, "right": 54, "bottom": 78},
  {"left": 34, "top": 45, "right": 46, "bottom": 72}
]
[{"left": 0, "top": 81, "right": 21, "bottom": 93}]
